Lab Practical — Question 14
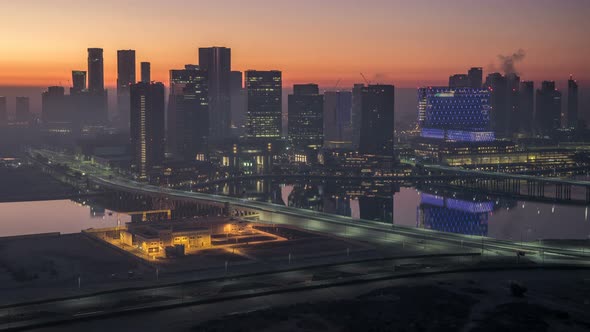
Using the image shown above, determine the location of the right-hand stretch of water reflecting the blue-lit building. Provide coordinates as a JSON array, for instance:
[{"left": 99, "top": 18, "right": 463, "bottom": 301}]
[{"left": 207, "top": 179, "right": 590, "bottom": 241}]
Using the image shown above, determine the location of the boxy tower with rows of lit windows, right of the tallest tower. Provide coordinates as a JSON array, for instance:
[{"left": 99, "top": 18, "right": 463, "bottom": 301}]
[{"left": 246, "top": 70, "right": 283, "bottom": 139}]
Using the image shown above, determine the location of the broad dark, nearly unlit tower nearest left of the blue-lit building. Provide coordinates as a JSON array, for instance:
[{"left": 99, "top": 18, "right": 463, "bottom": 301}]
[{"left": 359, "top": 85, "right": 395, "bottom": 156}]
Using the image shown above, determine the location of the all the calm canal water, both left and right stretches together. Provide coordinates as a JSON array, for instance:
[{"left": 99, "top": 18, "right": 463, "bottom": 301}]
[{"left": 0, "top": 180, "right": 590, "bottom": 241}]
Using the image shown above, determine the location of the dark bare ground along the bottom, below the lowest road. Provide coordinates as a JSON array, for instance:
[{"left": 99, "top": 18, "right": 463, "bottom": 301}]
[{"left": 30, "top": 270, "right": 590, "bottom": 332}]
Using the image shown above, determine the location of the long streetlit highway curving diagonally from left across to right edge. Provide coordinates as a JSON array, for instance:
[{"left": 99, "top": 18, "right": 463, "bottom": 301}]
[{"left": 28, "top": 150, "right": 590, "bottom": 261}]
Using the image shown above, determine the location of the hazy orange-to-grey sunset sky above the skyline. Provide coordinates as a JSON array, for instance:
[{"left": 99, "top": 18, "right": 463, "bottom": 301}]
[{"left": 0, "top": 0, "right": 590, "bottom": 87}]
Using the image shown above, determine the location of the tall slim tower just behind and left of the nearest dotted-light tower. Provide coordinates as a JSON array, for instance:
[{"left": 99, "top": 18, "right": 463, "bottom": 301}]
[{"left": 117, "top": 50, "right": 136, "bottom": 128}]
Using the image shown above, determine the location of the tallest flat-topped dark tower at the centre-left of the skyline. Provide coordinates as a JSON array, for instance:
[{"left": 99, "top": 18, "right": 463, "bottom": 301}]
[{"left": 199, "top": 47, "right": 231, "bottom": 138}]
